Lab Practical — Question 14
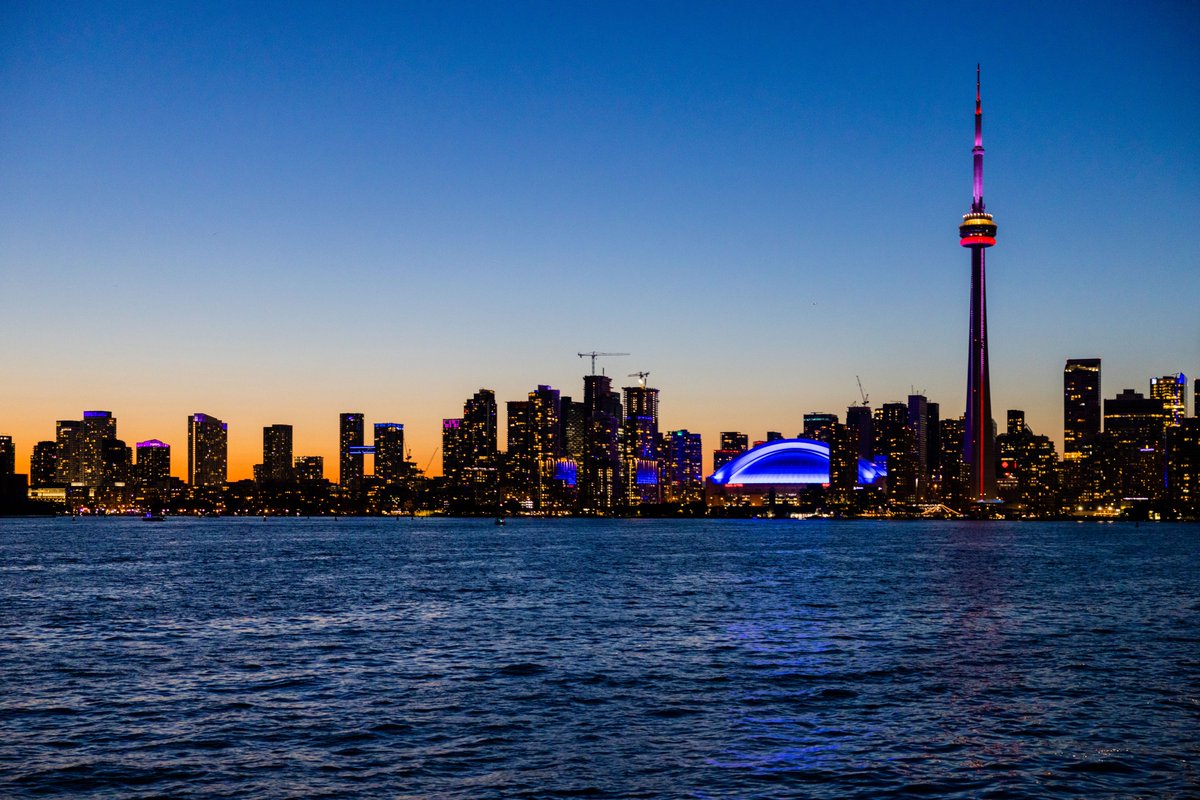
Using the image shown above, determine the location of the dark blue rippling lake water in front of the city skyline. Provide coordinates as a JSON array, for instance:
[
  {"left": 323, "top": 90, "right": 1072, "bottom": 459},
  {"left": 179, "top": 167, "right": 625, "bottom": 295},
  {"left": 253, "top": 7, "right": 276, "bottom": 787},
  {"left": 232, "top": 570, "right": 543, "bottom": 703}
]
[{"left": 0, "top": 519, "right": 1200, "bottom": 799}]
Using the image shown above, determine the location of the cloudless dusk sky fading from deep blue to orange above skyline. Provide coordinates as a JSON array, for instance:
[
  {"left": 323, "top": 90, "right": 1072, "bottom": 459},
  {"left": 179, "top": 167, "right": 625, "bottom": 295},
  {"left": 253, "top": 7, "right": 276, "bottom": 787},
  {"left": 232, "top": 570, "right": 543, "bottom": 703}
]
[{"left": 0, "top": 2, "right": 1200, "bottom": 479}]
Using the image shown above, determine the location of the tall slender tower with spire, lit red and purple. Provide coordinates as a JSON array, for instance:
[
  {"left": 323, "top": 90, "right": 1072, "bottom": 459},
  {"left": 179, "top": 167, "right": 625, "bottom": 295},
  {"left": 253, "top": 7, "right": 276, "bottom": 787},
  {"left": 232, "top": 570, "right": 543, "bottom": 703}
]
[{"left": 959, "top": 65, "right": 997, "bottom": 503}]
